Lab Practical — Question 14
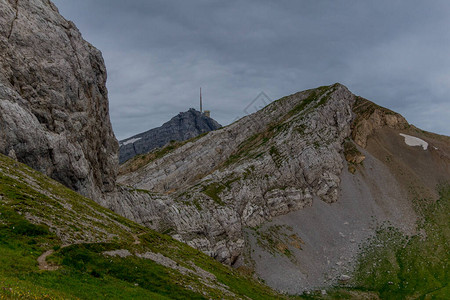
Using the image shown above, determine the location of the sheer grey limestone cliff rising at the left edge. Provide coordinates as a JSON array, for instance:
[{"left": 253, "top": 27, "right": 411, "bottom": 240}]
[{"left": 0, "top": 0, "right": 118, "bottom": 198}]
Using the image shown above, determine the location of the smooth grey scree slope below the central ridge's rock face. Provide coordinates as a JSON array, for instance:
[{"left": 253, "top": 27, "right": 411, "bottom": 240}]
[{"left": 247, "top": 145, "right": 416, "bottom": 294}]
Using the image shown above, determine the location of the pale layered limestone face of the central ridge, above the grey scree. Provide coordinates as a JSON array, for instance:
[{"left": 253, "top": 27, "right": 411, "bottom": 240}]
[{"left": 115, "top": 84, "right": 355, "bottom": 263}]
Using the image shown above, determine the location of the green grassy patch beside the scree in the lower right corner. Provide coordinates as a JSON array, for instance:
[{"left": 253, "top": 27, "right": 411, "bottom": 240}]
[{"left": 356, "top": 185, "right": 450, "bottom": 299}]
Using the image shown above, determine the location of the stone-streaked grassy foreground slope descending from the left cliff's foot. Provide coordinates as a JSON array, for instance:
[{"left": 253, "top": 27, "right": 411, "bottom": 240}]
[{"left": 0, "top": 155, "right": 281, "bottom": 299}]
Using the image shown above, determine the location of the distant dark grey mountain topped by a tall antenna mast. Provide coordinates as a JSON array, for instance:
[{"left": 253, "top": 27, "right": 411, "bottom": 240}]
[{"left": 119, "top": 108, "right": 222, "bottom": 163}]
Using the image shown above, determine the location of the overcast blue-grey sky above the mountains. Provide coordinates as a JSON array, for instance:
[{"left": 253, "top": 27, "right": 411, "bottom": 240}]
[{"left": 53, "top": 0, "right": 450, "bottom": 139}]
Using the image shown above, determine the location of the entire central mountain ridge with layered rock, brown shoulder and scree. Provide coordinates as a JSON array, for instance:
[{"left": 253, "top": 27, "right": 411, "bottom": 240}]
[{"left": 117, "top": 84, "right": 450, "bottom": 293}]
